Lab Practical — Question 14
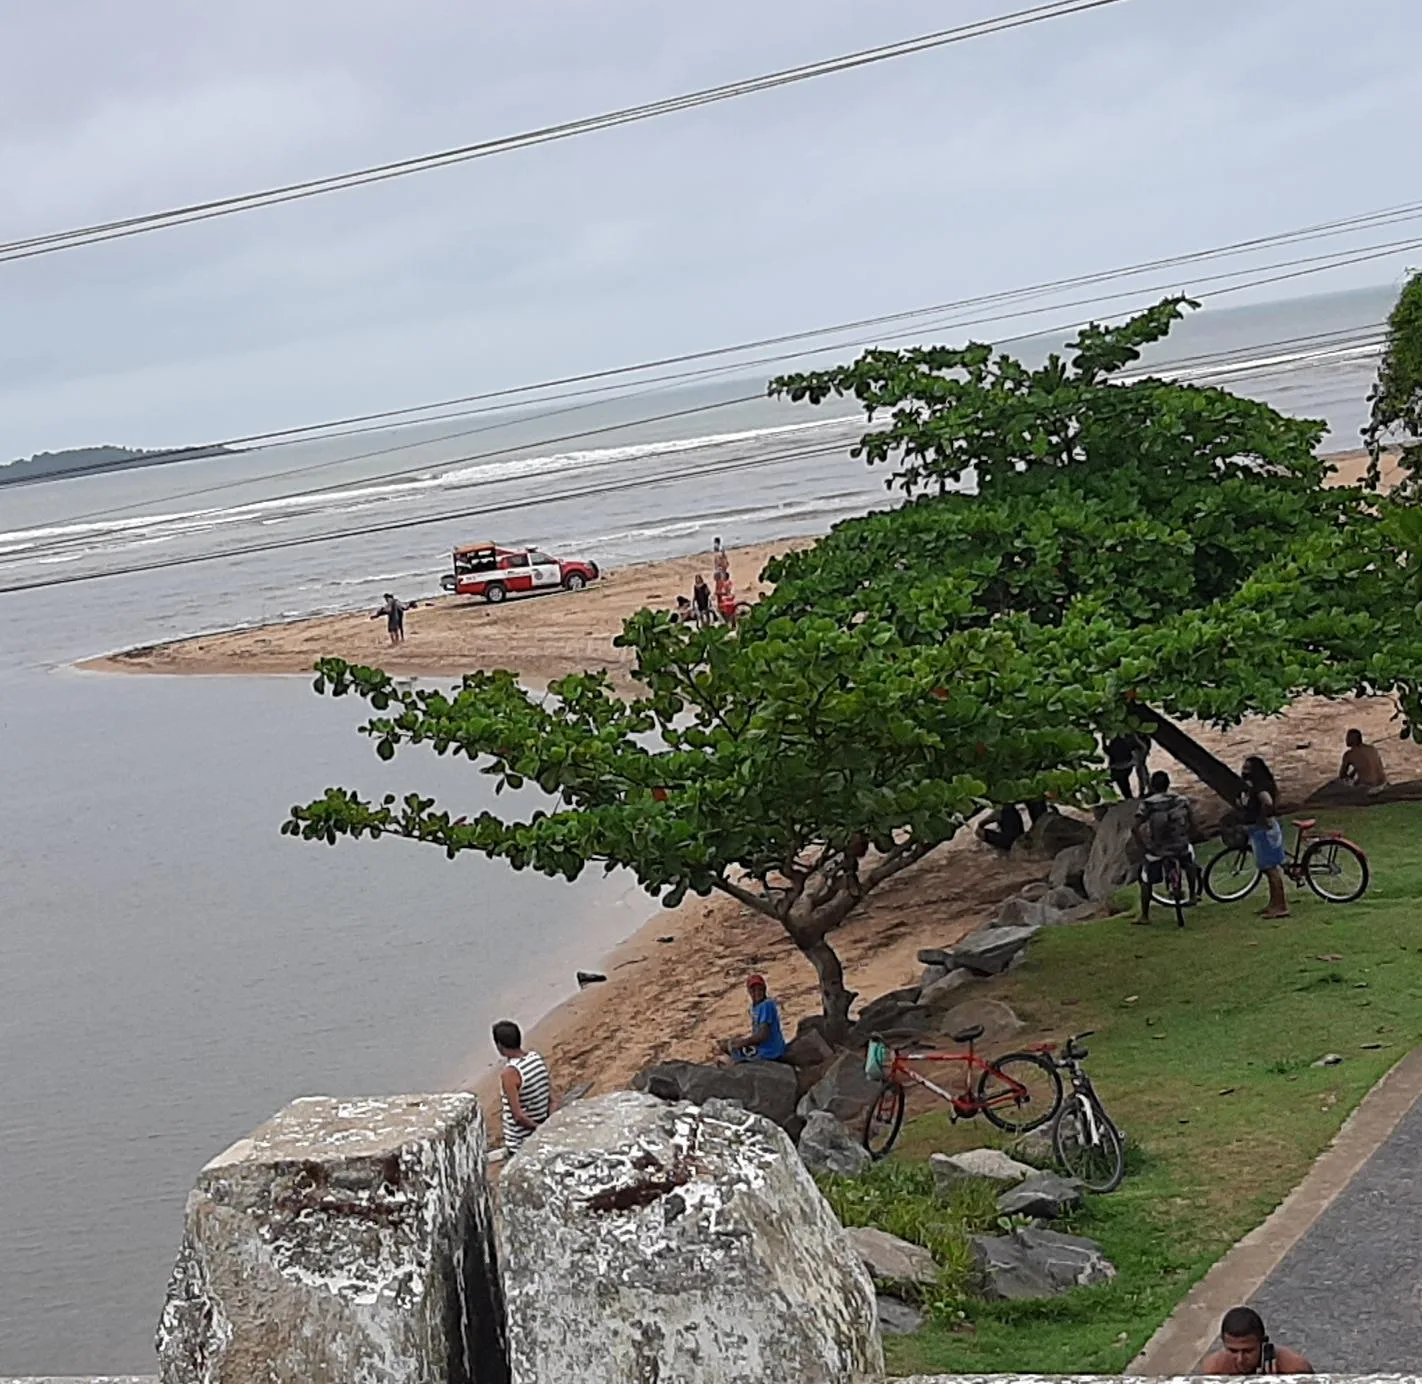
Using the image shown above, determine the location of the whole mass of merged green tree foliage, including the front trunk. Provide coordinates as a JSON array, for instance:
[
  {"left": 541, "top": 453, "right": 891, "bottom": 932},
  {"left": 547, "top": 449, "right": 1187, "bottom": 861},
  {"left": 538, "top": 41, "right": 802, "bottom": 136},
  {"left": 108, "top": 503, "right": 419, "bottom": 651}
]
[{"left": 283, "top": 299, "right": 1422, "bottom": 1028}]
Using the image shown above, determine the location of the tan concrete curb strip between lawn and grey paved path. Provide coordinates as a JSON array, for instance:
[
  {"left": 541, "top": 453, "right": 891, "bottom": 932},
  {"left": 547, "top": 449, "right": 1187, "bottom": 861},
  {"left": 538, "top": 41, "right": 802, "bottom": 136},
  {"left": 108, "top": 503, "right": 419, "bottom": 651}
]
[{"left": 1126, "top": 1048, "right": 1422, "bottom": 1375}]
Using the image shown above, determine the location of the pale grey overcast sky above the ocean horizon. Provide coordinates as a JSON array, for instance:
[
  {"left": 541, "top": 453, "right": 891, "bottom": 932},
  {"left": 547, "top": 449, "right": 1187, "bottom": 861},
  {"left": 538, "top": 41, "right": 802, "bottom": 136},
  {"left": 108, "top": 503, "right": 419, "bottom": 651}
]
[{"left": 0, "top": 0, "right": 1422, "bottom": 459}]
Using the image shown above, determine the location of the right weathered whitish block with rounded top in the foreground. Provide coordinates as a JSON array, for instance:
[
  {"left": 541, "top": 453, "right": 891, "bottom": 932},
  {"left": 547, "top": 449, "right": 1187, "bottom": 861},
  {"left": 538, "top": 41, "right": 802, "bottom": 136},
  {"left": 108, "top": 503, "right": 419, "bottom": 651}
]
[{"left": 499, "top": 1091, "right": 883, "bottom": 1384}]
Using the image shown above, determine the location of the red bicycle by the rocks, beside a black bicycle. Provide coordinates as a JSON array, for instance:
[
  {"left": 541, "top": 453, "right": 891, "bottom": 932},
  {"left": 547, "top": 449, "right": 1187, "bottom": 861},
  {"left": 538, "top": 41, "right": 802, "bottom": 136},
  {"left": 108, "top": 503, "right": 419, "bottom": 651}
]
[{"left": 865, "top": 1024, "right": 1062, "bottom": 1159}]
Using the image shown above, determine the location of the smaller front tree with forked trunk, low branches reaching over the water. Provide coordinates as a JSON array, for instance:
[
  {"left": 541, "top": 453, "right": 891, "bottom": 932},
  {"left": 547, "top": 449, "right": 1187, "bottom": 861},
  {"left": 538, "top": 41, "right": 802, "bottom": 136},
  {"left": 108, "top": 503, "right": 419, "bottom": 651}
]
[{"left": 283, "top": 610, "right": 1098, "bottom": 1031}]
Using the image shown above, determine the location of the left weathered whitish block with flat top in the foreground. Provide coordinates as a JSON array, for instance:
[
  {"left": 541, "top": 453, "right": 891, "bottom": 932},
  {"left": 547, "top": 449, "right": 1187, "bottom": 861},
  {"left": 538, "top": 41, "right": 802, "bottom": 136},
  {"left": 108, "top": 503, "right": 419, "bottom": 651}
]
[{"left": 158, "top": 1094, "right": 508, "bottom": 1384}]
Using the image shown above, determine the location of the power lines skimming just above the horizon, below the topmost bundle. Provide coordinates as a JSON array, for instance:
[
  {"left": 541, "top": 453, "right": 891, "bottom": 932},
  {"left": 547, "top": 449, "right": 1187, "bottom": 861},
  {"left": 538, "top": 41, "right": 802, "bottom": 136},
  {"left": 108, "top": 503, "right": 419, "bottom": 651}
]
[{"left": 13, "top": 192, "right": 1422, "bottom": 494}]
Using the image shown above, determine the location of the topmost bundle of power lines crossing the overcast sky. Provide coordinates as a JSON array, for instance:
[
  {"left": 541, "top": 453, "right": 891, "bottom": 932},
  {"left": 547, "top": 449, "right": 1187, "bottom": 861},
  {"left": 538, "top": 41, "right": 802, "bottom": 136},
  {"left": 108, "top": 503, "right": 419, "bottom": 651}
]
[{"left": 0, "top": 0, "right": 1122, "bottom": 262}]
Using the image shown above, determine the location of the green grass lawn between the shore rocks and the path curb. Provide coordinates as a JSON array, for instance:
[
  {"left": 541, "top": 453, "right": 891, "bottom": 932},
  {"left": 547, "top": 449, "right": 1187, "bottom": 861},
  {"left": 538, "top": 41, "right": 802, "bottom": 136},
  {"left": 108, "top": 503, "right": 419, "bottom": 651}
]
[{"left": 853, "top": 805, "right": 1422, "bottom": 1374}]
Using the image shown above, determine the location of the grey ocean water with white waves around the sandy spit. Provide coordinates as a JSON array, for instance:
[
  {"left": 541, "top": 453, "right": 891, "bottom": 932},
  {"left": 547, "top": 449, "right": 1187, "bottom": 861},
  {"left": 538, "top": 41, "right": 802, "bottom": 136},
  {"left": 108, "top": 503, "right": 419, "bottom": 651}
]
[{"left": 0, "top": 289, "right": 1392, "bottom": 1375}]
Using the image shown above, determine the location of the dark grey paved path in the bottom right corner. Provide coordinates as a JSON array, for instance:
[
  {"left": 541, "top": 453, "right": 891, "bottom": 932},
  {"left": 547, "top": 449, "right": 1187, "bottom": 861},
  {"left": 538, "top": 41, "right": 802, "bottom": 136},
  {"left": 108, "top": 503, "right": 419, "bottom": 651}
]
[{"left": 1250, "top": 1101, "right": 1422, "bottom": 1374}]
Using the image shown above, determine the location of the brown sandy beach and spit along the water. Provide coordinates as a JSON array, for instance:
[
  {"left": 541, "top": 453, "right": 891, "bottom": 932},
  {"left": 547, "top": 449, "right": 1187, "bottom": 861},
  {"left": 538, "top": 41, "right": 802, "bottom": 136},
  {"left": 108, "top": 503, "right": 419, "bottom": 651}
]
[{"left": 84, "top": 454, "right": 1422, "bottom": 1132}]
